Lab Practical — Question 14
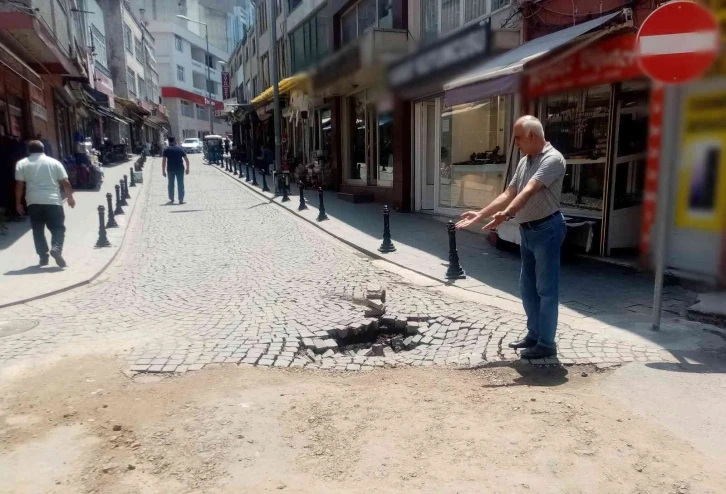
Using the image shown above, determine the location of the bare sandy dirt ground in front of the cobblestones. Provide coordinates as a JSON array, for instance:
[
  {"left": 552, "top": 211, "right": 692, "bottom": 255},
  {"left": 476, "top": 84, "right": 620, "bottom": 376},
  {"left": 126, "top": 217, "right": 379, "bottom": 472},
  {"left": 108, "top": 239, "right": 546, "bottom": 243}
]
[{"left": 0, "top": 357, "right": 726, "bottom": 494}]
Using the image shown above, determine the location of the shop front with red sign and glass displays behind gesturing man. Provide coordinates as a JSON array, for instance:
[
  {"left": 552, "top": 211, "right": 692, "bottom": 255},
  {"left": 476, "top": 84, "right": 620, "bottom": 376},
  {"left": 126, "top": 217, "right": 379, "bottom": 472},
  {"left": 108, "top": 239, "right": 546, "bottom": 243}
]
[{"left": 522, "top": 31, "right": 651, "bottom": 260}]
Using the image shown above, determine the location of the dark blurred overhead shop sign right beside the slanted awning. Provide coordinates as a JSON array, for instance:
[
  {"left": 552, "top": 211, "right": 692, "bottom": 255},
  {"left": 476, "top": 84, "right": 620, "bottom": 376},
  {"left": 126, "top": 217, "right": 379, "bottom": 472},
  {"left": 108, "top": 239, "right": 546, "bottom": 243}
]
[{"left": 388, "top": 21, "right": 491, "bottom": 89}]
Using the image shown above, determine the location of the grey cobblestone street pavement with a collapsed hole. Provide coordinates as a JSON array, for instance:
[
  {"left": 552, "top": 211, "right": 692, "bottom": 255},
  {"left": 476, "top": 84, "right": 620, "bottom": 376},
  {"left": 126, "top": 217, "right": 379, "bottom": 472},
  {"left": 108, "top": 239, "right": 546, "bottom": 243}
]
[{"left": 0, "top": 158, "right": 669, "bottom": 372}]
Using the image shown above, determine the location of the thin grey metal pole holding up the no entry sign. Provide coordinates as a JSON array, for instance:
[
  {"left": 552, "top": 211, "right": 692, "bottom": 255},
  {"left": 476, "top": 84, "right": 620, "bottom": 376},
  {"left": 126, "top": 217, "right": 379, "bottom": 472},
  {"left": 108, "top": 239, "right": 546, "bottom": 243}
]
[{"left": 651, "top": 86, "right": 681, "bottom": 331}]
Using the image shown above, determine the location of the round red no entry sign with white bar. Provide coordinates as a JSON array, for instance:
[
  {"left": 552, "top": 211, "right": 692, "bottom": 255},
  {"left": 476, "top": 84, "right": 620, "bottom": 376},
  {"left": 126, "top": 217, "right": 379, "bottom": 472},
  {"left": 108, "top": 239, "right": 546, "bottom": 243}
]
[{"left": 636, "top": 2, "right": 721, "bottom": 84}]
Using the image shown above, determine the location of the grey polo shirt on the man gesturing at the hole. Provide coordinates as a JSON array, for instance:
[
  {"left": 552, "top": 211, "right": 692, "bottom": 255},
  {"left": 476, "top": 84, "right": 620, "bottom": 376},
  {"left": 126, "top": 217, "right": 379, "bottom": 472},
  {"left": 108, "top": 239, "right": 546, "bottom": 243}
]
[{"left": 509, "top": 142, "right": 566, "bottom": 223}]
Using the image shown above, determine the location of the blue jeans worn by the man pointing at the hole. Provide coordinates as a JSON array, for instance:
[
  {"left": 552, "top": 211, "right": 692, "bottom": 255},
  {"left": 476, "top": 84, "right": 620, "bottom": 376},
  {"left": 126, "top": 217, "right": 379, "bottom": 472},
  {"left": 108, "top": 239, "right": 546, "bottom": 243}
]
[{"left": 519, "top": 213, "right": 567, "bottom": 348}]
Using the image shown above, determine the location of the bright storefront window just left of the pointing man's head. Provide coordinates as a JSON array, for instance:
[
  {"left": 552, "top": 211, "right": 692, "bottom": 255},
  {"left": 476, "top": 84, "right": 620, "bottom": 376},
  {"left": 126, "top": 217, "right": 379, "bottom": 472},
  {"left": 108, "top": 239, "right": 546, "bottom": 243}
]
[{"left": 439, "top": 96, "right": 512, "bottom": 209}]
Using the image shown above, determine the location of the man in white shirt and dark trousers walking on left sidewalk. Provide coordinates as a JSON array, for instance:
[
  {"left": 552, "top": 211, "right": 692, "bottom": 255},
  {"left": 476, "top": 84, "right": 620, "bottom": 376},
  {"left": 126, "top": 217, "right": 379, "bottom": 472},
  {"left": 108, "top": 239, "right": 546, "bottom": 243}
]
[{"left": 15, "top": 137, "right": 76, "bottom": 268}]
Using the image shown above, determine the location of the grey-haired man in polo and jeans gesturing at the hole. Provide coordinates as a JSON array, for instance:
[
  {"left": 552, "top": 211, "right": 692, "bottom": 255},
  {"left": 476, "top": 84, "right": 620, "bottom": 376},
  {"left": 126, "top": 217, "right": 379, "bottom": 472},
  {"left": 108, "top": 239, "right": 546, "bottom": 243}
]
[{"left": 456, "top": 115, "right": 566, "bottom": 359}]
